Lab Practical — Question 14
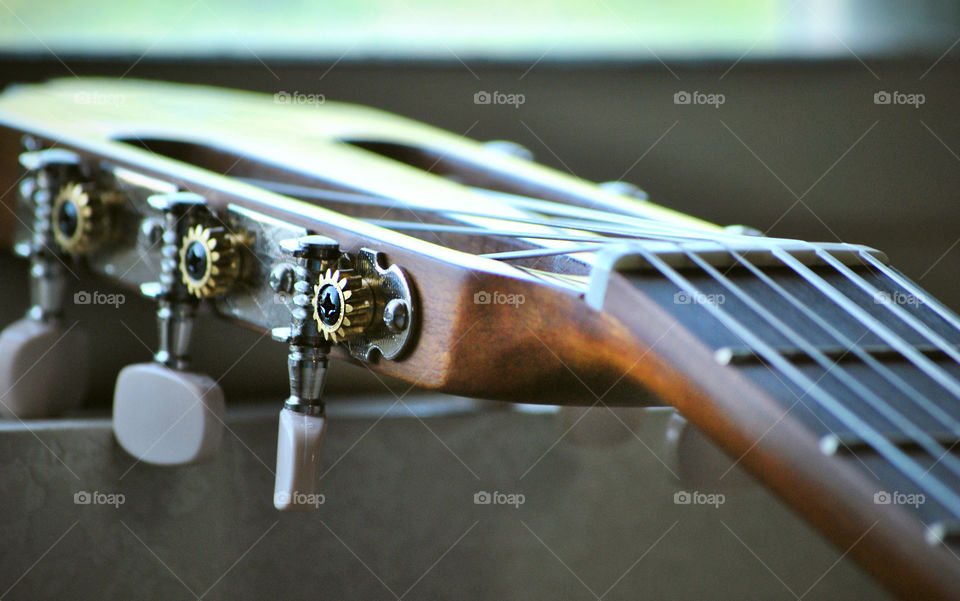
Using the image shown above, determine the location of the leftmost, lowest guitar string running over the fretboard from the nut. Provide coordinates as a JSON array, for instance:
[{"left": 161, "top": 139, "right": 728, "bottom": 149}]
[{"left": 637, "top": 245, "right": 960, "bottom": 517}]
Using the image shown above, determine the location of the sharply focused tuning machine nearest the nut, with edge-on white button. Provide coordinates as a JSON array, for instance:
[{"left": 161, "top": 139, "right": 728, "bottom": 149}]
[{"left": 271, "top": 235, "right": 413, "bottom": 509}]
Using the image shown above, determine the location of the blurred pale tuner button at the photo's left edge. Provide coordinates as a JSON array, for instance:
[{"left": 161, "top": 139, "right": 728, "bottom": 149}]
[{"left": 0, "top": 318, "right": 89, "bottom": 418}]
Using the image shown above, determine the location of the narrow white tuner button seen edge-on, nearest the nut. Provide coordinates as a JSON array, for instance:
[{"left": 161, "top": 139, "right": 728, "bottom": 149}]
[{"left": 273, "top": 407, "right": 327, "bottom": 510}]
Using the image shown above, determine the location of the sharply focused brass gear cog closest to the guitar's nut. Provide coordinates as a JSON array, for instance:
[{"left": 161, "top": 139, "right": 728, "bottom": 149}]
[{"left": 313, "top": 269, "right": 373, "bottom": 342}]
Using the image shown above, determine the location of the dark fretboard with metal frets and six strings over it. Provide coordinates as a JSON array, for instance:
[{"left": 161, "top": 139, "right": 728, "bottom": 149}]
[{"left": 635, "top": 250, "right": 960, "bottom": 544}]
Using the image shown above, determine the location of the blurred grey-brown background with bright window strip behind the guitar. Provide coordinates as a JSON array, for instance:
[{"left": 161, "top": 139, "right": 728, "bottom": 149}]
[{"left": 0, "top": 0, "right": 960, "bottom": 599}]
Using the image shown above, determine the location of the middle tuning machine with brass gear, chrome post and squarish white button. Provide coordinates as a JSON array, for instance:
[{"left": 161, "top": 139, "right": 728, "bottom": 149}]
[{"left": 113, "top": 192, "right": 231, "bottom": 465}]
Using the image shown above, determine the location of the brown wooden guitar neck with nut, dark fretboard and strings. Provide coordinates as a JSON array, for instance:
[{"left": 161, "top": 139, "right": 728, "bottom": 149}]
[{"left": 593, "top": 245, "right": 960, "bottom": 598}]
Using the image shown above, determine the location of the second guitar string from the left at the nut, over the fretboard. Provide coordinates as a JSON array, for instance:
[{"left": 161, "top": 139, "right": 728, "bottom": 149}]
[{"left": 684, "top": 250, "right": 960, "bottom": 476}]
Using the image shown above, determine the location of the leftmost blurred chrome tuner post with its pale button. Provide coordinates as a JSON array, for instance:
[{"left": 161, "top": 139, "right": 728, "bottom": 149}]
[{"left": 0, "top": 149, "right": 88, "bottom": 418}]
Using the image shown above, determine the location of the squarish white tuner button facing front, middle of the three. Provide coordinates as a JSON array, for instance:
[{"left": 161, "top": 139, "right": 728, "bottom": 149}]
[{"left": 113, "top": 363, "right": 224, "bottom": 465}]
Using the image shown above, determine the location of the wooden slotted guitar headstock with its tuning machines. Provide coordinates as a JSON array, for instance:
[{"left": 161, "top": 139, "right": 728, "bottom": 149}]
[{"left": 0, "top": 80, "right": 752, "bottom": 508}]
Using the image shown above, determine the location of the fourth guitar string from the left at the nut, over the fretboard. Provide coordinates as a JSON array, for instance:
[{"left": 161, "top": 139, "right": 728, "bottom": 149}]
[{"left": 773, "top": 248, "right": 960, "bottom": 398}]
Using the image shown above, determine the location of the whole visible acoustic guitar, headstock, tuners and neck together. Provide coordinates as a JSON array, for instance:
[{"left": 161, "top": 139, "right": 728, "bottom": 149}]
[{"left": 0, "top": 79, "right": 960, "bottom": 599}]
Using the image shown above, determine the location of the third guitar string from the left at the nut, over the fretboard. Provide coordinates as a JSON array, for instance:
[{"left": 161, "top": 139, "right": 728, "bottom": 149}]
[{"left": 727, "top": 244, "right": 960, "bottom": 446}]
